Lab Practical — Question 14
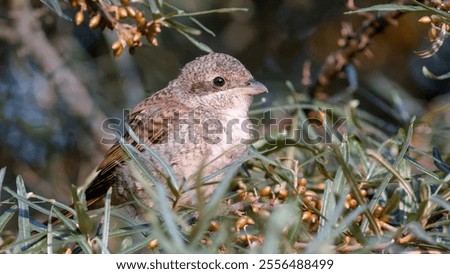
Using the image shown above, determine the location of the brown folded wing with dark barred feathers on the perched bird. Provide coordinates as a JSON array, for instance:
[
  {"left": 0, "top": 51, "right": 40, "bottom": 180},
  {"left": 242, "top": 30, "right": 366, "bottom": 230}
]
[{"left": 85, "top": 90, "right": 172, "bottom": 208}]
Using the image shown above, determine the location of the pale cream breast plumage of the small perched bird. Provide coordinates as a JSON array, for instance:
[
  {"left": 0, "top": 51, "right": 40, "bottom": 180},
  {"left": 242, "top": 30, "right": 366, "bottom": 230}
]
[{"left": 160, "top": 109, "right": 252, "bottom": 182}]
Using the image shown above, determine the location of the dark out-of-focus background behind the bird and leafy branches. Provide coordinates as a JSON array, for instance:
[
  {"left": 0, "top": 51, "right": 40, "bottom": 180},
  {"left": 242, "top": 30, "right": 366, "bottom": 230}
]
[{"left": 0, "top": 0, "right": 450, "bottom": 206}]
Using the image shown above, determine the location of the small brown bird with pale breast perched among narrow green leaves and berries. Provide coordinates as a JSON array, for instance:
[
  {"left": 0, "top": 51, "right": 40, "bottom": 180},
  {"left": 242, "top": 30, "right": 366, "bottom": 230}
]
[{"left": 84, "top": 53, "right": 268, "bottom": 217}]
